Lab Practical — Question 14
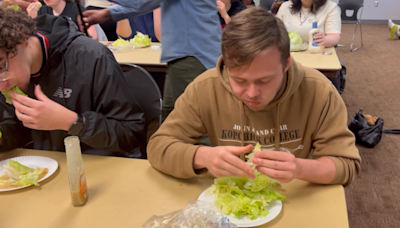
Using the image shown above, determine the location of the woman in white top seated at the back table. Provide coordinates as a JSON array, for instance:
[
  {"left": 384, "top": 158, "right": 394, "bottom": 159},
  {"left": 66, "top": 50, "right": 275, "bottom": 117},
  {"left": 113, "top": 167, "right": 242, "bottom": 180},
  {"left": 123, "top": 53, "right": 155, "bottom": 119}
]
[{"left": 276, "top": 0, "right": 342, "bottom": 47}]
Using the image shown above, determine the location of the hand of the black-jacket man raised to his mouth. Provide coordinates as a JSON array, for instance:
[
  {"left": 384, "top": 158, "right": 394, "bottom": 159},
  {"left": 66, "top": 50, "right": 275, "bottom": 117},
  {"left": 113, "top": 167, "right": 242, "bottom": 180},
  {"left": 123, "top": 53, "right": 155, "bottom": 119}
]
[{"left": 11, "top": 86, "right": 78, "bottom": 131}]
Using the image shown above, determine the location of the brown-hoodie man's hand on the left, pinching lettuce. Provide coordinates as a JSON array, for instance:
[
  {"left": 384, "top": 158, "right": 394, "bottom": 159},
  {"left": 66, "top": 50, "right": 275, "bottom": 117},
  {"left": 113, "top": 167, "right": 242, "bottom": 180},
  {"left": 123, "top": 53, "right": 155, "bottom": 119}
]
[{"left": 194, "top": 145, "right": 254, "bottom": 179}]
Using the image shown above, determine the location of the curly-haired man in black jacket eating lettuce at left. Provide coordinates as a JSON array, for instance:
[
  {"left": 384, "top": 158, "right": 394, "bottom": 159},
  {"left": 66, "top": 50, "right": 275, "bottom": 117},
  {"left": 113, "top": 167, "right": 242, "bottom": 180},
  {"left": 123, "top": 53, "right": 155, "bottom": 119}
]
[{"left": 0, "top": 9, "right": 144, "bottom": 157}]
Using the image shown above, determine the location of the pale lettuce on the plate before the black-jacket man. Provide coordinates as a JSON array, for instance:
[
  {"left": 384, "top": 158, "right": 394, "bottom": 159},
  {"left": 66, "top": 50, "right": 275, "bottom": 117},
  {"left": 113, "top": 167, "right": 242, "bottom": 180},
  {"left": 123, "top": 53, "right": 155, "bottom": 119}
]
[{"left": 0, "top": 160, "right": 48, "bottom": 189}]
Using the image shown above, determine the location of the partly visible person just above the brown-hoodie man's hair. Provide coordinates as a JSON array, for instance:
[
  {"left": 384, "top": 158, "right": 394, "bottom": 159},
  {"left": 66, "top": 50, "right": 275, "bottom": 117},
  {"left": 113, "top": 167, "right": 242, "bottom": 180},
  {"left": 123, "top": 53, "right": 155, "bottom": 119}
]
[{"left": 217, "top": 0, "right": 247, "bottom": 29}]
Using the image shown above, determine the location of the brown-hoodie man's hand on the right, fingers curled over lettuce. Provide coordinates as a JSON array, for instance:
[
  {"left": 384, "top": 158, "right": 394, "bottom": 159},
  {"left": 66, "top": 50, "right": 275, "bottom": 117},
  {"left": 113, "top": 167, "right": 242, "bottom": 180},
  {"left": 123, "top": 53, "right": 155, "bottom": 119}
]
[{"left": 253, "top": 151, "right": 299, "bottom": 183}]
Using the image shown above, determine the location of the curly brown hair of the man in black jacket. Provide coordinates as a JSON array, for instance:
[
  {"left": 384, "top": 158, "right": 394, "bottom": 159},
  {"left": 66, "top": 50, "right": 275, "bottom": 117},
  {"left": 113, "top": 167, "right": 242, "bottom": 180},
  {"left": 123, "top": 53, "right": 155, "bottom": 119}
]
[{"left": 0, "top": 9, "right": 37, "bottom": 54}]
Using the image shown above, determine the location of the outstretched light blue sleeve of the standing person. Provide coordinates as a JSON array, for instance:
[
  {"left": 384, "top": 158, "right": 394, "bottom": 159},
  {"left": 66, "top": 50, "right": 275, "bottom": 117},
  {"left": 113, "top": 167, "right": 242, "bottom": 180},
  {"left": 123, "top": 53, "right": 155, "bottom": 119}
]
[{"left": 108, "top": 0, "right": 164, "bottom": 21}]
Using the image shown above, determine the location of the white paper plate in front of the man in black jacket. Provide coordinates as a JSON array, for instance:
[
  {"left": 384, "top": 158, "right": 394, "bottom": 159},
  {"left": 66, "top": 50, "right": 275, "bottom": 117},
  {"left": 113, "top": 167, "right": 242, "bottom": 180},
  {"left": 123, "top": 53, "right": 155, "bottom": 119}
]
[{"left": 0, "top": 156, "right": 58, "bottom": 192}]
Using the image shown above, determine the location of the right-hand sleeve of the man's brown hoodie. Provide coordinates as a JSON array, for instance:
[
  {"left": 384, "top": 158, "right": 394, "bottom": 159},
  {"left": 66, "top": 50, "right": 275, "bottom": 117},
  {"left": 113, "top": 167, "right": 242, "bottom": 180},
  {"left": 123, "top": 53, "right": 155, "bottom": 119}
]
[{"left": 313, "top": 86, "right": 361, "bottom": 186}]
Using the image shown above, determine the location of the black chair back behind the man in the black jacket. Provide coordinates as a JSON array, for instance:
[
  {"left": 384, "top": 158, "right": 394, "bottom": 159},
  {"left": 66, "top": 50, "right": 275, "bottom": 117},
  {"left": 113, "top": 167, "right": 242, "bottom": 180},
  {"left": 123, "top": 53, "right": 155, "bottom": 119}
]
[{"left": 120, "top": 63, "right": 162, "bottom": 159}]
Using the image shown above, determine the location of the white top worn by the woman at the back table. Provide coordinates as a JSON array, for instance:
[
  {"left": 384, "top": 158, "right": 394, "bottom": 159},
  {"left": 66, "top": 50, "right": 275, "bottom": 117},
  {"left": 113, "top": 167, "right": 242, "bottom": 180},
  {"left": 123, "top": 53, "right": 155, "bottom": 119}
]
[{"left": 276, "top": 0, "right": 342, "bottom": 42}]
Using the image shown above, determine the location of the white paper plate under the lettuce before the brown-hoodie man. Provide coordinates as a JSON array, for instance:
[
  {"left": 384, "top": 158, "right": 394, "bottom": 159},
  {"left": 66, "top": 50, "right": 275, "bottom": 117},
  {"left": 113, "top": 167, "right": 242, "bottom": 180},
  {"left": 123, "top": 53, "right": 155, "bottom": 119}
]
[{"left": 198, "top": 189, "right": 282, "bottom": 227}]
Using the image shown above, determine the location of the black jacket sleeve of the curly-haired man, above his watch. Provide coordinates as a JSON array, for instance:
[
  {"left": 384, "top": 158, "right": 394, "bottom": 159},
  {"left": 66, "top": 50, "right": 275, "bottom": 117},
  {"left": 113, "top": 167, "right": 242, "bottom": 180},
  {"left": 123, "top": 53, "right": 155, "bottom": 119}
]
[{"left": 80, "top": 49, "right": 144, "bottom": 152}]
